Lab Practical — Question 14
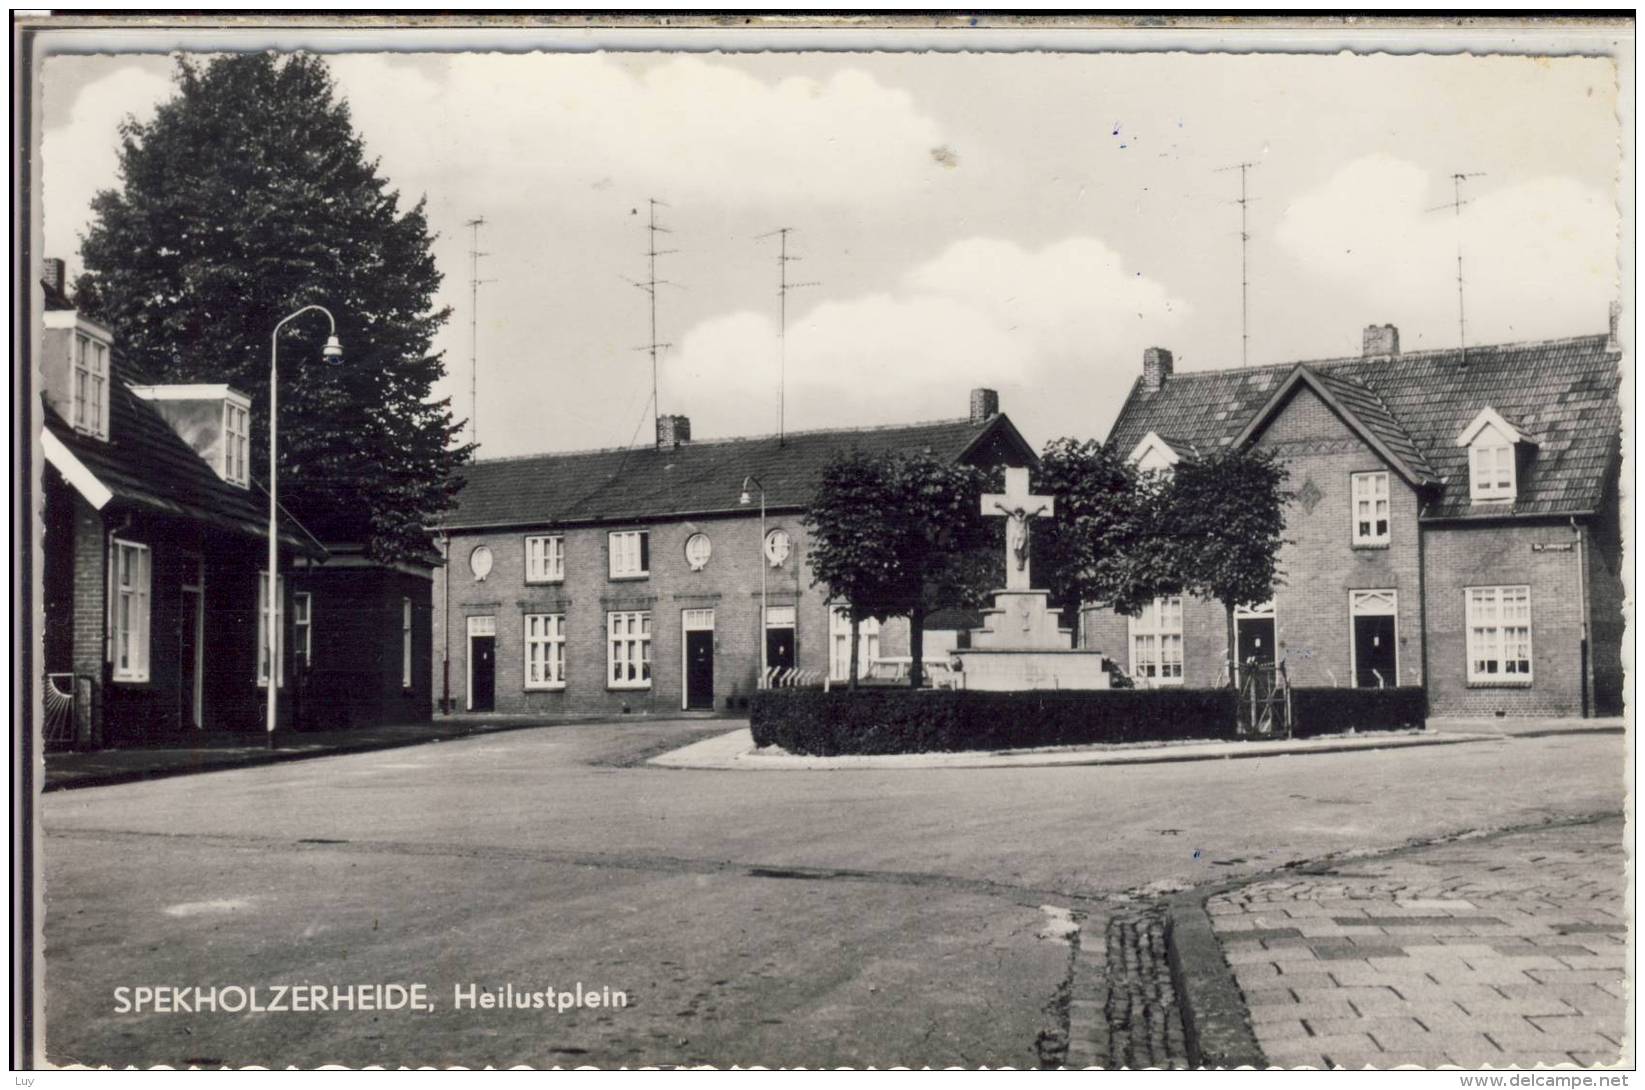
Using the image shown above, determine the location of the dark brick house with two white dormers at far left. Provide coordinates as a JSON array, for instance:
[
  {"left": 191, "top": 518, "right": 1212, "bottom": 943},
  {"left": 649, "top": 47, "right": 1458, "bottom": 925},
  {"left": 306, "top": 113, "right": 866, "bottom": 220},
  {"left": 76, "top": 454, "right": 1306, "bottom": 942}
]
[{"left": 35, "top": 272, "right": 324, "bottom": 746}]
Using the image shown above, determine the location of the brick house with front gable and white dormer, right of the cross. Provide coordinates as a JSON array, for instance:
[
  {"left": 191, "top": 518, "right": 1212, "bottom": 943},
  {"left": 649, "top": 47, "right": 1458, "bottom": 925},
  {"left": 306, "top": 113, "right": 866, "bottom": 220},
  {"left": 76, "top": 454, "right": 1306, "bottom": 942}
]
[{"left": 1081, "top": 316, "right": 1624, "bottom": 715}]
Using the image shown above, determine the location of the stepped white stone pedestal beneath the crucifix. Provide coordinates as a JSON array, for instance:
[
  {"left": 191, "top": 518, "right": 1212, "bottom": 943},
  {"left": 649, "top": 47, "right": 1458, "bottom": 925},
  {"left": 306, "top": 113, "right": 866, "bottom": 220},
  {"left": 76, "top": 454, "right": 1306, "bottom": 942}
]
[{"left": 954, "top": 589, "right": 1109, "bottom": 692}]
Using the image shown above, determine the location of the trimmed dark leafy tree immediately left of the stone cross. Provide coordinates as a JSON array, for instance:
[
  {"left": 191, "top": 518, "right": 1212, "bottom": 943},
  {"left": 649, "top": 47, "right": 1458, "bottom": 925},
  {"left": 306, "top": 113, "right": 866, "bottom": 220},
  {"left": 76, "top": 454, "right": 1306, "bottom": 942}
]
[{"left": 806, "top": 450, "right": 1003, "bottom": 689}]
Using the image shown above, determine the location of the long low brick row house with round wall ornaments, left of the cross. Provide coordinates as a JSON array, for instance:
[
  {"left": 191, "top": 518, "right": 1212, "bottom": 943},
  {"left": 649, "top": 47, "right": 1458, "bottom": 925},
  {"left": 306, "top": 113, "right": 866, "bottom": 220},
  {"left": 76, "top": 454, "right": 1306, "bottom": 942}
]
[{"left": 434, "top": 390, "right": 1035, "bottom": 714}]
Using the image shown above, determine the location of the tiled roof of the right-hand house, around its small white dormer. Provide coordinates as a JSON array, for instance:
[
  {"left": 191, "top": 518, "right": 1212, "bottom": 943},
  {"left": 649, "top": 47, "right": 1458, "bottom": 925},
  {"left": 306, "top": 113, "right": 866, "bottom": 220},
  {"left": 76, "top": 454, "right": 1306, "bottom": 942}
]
[{"left": 1109, "top": 334, "right": 1622, "bottom": 518}]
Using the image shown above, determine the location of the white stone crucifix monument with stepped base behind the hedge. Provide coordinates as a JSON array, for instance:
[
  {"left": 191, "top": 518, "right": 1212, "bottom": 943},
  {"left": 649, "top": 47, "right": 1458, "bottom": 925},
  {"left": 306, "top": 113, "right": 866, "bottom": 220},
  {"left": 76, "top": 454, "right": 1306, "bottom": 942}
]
[{"left": 954, "top": 465, "right": 1109, "bottom": 690}]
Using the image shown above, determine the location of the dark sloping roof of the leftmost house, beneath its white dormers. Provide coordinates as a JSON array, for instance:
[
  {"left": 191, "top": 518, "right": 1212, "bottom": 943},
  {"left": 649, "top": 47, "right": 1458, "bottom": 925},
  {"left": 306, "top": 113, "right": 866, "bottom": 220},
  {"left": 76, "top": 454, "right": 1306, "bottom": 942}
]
[{"left": 44, "top": 358, "right": 324, "bottom": 556}]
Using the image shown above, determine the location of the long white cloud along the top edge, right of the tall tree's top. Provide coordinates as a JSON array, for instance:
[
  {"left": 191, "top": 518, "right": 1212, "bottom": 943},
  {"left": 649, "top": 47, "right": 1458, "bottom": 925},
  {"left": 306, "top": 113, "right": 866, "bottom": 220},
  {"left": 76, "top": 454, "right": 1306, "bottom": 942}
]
[{"left": 331, "top": 54, "right": 944, "bottom": 207}]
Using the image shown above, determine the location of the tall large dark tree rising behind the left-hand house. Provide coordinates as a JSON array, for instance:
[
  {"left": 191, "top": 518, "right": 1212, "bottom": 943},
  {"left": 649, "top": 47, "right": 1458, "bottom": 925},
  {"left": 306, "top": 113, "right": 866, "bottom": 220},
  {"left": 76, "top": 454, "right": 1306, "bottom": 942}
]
[{"left": 79, "top": 54, "right": 472, "bottom": 559}]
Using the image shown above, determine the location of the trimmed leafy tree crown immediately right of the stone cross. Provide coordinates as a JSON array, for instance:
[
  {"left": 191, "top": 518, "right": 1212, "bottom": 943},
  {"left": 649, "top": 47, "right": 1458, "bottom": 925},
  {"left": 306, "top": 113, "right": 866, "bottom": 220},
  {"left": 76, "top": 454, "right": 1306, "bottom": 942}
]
[{"left": 1035, "top": 439, "right": 1178, "bottom": 618}]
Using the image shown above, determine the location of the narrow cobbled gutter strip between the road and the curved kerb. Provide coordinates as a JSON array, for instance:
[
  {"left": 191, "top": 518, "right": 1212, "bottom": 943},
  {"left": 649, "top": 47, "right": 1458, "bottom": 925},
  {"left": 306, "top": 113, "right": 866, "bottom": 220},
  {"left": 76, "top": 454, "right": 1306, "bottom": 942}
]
[{"left": 1068, "top": 904, "right": 1188, "bottom": 1070}]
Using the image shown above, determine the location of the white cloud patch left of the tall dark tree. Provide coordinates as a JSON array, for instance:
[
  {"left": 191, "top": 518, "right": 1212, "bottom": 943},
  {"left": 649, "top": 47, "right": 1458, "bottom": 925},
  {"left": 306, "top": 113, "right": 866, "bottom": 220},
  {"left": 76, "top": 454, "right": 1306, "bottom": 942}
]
[{"left": 39, "top": 61, "right": 171, "bottom": 271}]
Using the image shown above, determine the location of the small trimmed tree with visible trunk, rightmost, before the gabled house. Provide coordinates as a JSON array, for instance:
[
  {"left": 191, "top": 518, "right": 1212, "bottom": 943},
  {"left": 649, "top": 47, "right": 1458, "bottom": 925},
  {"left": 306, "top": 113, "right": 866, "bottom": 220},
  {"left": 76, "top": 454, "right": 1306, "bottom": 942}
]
[{"left": 1165, "top": 447, "right": 1286, "bottom": 684}]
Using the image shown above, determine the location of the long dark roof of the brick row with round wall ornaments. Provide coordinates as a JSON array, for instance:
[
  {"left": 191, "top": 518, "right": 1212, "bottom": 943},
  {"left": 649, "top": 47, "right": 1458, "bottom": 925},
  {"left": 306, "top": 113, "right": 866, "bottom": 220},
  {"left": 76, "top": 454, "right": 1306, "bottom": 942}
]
[{"left": 443, "top": 414, "right": 1036, "bottom": 529}]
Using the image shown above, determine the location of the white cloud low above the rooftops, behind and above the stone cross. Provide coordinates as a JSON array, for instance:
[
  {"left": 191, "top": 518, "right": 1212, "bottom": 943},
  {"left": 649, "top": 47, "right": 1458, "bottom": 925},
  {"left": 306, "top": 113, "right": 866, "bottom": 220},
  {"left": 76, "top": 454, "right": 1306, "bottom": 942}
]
[{"left": 668, "top": 238, "right": 1188, "bottom": 442}]
